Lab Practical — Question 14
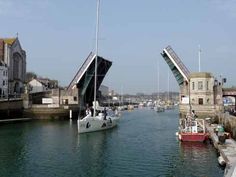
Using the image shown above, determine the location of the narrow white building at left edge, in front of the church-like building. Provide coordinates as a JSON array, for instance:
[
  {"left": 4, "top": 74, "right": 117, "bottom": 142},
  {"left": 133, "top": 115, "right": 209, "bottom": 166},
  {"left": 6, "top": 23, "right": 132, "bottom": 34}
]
[{"left": 0, "top": 60, "right": 8, "bottom": 99}]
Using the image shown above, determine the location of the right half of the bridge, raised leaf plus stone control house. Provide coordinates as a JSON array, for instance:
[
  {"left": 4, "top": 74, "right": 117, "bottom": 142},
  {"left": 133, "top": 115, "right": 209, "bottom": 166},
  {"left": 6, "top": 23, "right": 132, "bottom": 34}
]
[{"left": 161, "top": 46, "right": 236, "bottom": 117}]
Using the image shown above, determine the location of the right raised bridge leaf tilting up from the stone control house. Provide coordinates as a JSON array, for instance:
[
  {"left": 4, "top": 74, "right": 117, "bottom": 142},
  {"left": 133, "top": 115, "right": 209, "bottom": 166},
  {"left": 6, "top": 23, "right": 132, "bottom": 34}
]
[{"left": 161, "top": 46, "right": 190, "bottom": 86}]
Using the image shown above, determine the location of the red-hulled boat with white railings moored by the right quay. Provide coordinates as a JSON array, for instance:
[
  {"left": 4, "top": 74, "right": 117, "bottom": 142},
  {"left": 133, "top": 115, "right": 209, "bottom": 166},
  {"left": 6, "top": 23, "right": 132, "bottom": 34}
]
[{"left": 178, "top": 116, "right": 209, "bottom": 142}]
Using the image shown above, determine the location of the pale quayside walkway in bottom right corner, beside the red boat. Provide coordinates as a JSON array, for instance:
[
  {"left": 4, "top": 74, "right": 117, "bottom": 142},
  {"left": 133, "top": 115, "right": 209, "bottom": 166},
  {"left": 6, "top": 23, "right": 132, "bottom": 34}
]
[{"left": 206, "top": 124, "right": 236, "bottom": 177}]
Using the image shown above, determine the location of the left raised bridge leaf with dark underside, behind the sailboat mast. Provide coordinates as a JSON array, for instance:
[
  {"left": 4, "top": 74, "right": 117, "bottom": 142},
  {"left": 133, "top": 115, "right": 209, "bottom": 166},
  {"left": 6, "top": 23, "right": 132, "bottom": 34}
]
[{"left": 69, "top": 53, "right": 112, "bottom": 107}]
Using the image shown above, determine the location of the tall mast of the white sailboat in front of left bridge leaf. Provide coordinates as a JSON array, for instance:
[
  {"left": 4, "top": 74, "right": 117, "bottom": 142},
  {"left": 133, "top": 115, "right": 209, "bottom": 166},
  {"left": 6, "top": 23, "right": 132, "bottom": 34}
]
[{"left": 93, "top": 0, "right": 100, "bottom": 117}]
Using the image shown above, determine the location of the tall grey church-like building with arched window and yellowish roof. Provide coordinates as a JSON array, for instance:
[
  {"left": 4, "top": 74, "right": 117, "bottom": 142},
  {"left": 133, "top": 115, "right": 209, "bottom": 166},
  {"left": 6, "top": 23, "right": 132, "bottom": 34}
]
[{"left": 0, "top": 38, "right": 26, "bottom": 95}]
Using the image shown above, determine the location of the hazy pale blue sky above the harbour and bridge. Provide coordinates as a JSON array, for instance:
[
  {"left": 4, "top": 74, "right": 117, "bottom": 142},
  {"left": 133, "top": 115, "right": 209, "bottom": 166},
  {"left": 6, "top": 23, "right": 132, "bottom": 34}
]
[{"left": 0, "top": 0, "right": 236, "bottom": 94}]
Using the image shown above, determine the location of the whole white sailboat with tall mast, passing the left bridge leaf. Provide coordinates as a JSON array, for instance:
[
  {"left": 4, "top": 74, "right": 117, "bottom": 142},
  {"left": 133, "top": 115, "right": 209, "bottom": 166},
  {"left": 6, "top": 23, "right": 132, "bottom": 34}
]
[{"left": 78, "top": 0, "right": 120, "bottom": 133}]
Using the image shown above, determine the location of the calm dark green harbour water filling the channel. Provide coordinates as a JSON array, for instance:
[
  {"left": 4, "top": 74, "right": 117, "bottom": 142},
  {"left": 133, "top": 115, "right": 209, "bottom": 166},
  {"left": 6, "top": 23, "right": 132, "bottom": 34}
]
[{"left": 0, "top": 109, "right": 224, "bottom": 177}]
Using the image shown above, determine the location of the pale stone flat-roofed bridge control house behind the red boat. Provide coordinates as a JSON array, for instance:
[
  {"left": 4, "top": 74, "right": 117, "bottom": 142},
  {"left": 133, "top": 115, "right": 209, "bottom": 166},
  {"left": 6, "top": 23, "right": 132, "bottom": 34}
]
[{"left": 180, "top": 72, "right": 223, "bottom": 117}]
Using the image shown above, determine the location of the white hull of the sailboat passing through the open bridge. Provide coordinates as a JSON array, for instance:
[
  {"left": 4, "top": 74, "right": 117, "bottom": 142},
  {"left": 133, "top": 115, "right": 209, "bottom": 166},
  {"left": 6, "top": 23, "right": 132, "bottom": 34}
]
[{"left": 78, "top": 115, "right": 120, "bottom": 133}]
